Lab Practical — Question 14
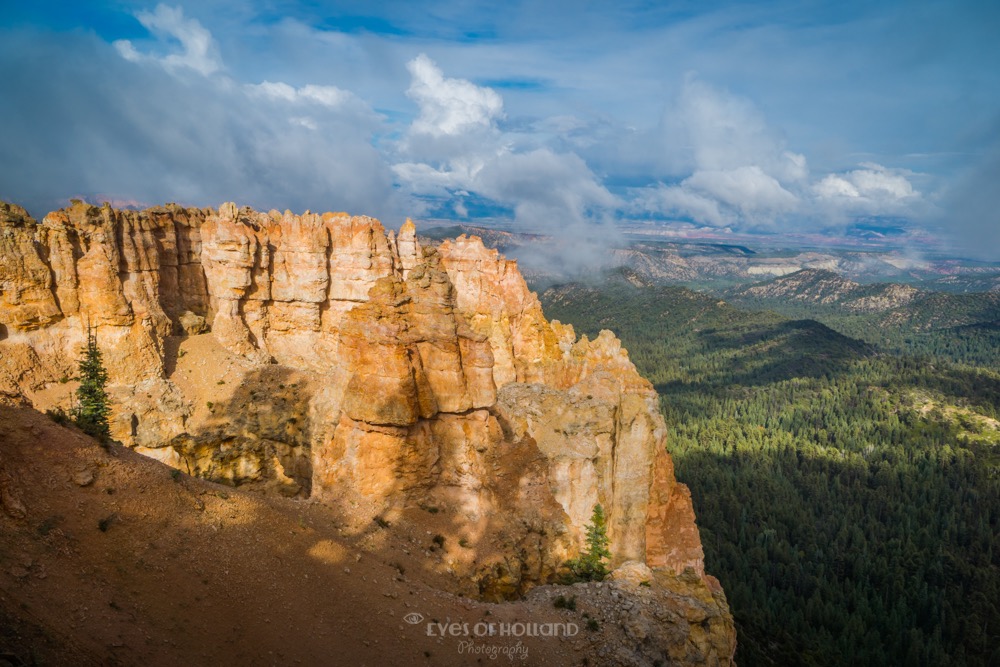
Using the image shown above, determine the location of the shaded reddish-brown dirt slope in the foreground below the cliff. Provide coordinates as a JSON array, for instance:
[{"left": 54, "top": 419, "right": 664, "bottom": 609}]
[{"left": 0, "top": 407, "right": 736, "bottom": 666}]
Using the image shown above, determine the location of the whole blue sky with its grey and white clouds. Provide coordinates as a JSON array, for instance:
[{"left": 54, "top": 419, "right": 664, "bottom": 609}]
[{"left": 0, "top": 0, "right": 1000, "bottom": 259}]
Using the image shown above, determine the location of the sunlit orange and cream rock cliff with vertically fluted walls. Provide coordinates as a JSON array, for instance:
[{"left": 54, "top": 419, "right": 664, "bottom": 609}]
[{"left": 0, "top": 203, "right": 728, "bottom": 656}]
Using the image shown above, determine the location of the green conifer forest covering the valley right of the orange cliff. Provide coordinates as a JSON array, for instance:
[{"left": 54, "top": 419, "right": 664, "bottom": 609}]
[{"left": 542, "top": 284, "right": 1000, "bottom": 666}]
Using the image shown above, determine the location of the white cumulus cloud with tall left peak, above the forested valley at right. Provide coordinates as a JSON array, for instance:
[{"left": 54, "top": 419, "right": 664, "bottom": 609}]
[{"left": 630, "top": 77, "right": 926, "bottom": 227}]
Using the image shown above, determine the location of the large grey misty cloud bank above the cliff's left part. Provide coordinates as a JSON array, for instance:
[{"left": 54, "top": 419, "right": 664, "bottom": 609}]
[{"left": 0, "top": 5, "right": 407, "bottom": 220}]
